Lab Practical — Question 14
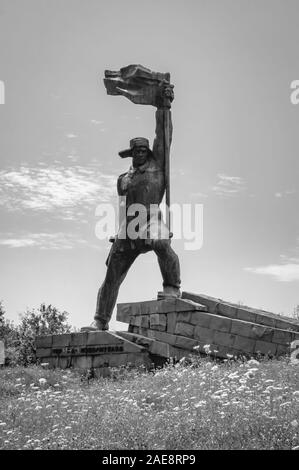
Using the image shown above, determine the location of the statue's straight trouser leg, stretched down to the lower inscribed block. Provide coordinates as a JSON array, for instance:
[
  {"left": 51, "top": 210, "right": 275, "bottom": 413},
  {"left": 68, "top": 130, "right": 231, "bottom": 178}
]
[{"left": 94, "top": 247, "right": 139, "bottom": 323}]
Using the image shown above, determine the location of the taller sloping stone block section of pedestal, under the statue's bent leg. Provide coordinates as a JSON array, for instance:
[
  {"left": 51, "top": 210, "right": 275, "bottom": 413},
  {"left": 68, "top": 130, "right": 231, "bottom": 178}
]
[{"left": 117, "top": 292, "right": 299, "bottom": 359}]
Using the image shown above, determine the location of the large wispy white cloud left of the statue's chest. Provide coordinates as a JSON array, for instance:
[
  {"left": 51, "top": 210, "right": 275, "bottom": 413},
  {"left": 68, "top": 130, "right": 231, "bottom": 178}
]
[{"left": 0, "top": 164, "right": 116, "bottom": 220}]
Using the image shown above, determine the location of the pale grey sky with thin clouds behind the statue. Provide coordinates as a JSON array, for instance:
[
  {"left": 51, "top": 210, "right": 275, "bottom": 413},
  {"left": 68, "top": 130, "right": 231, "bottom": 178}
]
[{"left": 0, "top": 0, "right": 299, "bottom": 329}]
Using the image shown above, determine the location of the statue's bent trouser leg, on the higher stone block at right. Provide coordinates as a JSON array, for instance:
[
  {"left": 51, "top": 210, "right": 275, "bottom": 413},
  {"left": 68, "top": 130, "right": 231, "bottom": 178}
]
[{"left": 152, "top": 239, "right": 181, "bottom": 289}]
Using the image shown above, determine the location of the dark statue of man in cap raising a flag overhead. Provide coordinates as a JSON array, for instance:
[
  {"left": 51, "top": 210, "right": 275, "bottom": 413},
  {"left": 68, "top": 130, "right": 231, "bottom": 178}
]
[{"left": 92, "top": 65, "right": 181, "bottom": 330}]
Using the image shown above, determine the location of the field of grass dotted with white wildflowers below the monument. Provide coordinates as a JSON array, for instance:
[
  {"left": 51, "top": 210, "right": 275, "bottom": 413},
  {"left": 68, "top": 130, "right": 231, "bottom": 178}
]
[{"left": 0, "top": 358, "right": 299, "bottom": 450}]
